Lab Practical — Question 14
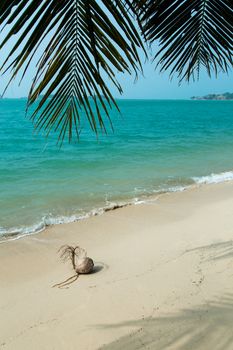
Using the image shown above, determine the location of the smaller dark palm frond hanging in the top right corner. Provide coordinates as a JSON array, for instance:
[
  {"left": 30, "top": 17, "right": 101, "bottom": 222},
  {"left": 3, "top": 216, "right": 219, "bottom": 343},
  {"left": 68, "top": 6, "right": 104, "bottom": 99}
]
[{"left": 133, "top": 0, "right": 233, "bottom": 81}]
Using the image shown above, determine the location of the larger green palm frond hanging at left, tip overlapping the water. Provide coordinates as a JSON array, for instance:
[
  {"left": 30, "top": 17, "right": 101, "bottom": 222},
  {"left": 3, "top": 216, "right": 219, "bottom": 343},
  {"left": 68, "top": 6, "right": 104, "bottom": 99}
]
[{"left": 0, "top": 0, "right": 143, "bottom": 142}]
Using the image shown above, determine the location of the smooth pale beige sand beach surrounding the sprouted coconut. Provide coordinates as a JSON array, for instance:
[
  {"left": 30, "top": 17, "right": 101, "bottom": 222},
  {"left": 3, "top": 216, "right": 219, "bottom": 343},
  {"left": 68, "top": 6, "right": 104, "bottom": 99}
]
[{"left": 0, "top": 182, "right": 233, "bottom": 350}]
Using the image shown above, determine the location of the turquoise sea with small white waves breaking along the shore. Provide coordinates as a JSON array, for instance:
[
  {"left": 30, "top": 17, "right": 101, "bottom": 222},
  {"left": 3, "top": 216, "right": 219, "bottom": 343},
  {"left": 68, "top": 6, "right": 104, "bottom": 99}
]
[{"left": 0, "top": 99, "right": 233, "bottom": 235}]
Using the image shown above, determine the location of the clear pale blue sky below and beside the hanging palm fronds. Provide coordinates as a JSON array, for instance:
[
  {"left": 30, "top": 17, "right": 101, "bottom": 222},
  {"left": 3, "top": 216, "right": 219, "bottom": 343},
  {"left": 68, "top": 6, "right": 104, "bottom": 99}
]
[{"left": 0, "top": 12, "right": 233, "bottom": 99}]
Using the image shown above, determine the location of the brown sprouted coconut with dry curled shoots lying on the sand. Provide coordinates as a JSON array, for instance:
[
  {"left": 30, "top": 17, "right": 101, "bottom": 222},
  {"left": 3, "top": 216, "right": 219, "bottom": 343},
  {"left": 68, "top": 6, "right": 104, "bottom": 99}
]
[{"left": 53, "top": 245, "right": 94, "bottom": 288}]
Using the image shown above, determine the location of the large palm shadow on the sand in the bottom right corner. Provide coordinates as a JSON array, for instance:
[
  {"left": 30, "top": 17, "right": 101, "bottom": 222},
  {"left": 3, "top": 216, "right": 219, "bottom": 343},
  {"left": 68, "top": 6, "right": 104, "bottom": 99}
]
[{"left": 100, "top": 294, "right": 233, "bottom": 350}]
